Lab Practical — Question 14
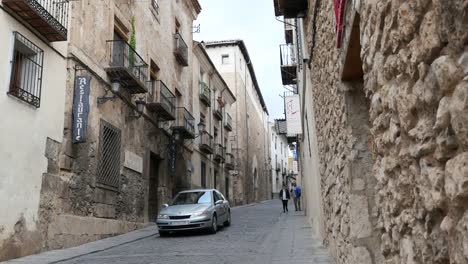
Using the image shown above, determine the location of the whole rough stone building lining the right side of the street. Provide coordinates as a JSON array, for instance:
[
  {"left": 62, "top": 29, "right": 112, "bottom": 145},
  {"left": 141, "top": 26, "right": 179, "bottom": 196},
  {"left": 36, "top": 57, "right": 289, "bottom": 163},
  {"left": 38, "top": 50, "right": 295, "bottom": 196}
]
[{"left": 274, "top": 0, "right": 468, "bottom": 264}]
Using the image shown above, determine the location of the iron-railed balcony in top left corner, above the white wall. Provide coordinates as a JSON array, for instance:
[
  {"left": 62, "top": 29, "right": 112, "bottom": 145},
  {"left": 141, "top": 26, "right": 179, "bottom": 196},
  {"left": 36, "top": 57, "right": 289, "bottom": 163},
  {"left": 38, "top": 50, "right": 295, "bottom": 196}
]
[{"left": 2, "top": 0, "right": 69, "bottom": 42}]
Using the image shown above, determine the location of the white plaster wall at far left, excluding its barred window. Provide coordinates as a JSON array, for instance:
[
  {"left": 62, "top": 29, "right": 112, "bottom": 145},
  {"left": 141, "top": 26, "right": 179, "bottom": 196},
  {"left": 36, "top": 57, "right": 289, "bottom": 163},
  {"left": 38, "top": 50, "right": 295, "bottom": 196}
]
[{"left": 0, "top": 10, "right": 66, "bottom": 242}]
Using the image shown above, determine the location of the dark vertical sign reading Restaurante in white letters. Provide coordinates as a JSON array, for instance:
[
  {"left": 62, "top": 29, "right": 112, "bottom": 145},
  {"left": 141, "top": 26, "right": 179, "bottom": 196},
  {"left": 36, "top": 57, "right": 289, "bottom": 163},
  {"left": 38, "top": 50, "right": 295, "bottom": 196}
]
[{"left": 72, "top": 76, "right": 91, "bottom": 144}]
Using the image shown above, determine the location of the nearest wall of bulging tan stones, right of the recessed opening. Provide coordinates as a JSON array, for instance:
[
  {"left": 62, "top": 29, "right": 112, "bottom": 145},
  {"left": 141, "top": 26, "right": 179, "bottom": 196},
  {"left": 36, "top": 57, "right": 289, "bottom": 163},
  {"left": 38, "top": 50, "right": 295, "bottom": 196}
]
[{"left": 360, "top": 0, "right": 468, "bottom": 264}]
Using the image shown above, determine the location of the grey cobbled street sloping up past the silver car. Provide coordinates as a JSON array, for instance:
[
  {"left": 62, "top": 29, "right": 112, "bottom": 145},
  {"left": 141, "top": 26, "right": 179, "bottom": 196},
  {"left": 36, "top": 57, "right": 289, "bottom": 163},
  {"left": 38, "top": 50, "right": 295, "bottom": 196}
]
[{"left": 4, "top": 201, "right": 333, "bottom": 264}]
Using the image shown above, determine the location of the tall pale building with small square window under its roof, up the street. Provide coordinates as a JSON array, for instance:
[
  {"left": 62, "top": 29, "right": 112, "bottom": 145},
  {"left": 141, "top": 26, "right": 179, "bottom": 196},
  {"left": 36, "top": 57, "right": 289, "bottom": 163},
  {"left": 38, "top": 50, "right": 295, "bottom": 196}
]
[{"left": 205, "top": 40, "right": 271, "bottom": 205}]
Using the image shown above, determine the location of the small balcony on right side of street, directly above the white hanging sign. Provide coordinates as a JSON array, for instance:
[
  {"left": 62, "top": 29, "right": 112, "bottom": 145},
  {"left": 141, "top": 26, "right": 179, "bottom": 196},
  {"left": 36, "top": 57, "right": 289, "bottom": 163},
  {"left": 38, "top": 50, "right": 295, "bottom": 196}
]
[{"left": 280, "top": 44, "right": 297, "bottom": 85}]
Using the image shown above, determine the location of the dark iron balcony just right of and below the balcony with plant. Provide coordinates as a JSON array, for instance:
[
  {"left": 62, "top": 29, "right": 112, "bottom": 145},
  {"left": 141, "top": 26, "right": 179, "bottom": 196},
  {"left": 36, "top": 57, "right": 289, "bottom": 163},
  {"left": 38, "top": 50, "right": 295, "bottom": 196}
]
[{"left": 146, "top": 80, "right": 175, "bottom": 121}]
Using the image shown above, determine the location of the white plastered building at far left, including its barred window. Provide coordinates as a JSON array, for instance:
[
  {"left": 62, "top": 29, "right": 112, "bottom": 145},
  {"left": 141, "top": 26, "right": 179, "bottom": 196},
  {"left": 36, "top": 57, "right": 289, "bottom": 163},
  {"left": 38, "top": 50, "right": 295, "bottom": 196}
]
[{"left": 0, "top": 1, "right": 67, "bottom": 261}]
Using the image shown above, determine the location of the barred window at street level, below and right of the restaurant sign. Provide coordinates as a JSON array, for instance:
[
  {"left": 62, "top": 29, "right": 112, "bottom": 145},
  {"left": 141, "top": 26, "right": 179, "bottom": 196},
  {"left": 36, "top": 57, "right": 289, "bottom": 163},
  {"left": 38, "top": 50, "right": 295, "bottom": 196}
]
[{"left": 97, "top": 120, "right": 120, "bottom": 190}]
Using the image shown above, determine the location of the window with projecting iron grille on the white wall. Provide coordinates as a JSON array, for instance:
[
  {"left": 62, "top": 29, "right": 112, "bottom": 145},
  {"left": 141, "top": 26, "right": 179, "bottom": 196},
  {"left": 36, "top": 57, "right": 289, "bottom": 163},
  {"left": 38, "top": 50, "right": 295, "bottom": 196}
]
[{"left": 8, "top": 32, "right": 44, "bottom": 108}]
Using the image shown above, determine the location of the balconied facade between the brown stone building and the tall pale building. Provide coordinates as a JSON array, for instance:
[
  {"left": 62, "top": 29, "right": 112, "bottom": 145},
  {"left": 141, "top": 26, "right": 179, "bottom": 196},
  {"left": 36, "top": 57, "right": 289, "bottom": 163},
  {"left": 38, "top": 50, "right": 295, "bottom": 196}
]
[{"left": 192, "top": 42, "right": 236, "bottom": 201}]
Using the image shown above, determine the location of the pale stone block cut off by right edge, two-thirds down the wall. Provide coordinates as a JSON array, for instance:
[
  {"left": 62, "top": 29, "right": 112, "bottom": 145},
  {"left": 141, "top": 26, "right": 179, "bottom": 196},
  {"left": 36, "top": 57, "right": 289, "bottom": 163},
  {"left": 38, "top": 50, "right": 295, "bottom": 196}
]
[{"left": 445, "top": 152, "right": 468, "bottom": 201}]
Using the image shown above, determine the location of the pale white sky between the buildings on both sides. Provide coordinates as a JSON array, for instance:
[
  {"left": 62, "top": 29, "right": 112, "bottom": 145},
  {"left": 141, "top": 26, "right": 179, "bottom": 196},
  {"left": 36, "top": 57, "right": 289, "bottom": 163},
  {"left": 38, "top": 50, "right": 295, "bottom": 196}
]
[{"left": 193, "top": 0, "right": 286, "bottom": 120}]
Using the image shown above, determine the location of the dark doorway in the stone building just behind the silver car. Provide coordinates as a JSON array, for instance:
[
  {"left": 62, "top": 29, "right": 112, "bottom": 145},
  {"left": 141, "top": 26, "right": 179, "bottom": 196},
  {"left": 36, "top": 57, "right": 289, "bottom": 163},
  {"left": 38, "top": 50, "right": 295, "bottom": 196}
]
[{"left": 148, "top": 152, "right": 161, "bottom": 222}]
